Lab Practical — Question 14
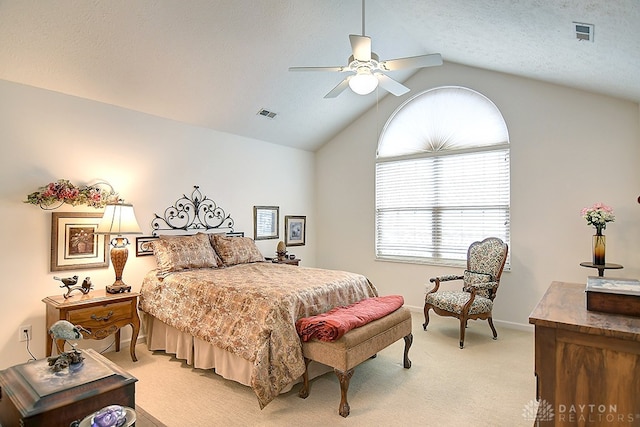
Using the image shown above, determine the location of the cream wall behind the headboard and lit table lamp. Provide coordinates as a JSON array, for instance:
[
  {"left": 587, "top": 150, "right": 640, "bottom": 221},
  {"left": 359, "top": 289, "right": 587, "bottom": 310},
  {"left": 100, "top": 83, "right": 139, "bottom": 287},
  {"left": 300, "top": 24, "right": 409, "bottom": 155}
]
[{"left": 0, "top": 80, "right": 316, "bottom": 369}]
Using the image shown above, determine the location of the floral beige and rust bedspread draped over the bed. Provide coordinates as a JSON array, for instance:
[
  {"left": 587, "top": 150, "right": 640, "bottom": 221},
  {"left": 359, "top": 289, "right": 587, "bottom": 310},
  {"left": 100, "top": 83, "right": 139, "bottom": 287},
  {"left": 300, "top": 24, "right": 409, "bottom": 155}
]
[{"left": 140, "top": 262, "right": 378, "bottom": 408}]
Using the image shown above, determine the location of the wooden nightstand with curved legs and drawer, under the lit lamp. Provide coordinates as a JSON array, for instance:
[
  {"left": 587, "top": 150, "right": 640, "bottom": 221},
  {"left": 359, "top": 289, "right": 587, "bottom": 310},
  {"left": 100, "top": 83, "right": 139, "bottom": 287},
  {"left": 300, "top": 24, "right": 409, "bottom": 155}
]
[{"left": 42, "top": 289, "right": 140, "bottom": 362}]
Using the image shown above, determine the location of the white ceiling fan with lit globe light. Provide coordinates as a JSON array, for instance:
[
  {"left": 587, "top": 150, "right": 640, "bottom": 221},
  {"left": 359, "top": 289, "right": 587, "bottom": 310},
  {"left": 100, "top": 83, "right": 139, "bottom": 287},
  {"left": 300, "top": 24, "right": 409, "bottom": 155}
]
[{"left": 289, "top": 0, "right": 442, "bottom": 98}]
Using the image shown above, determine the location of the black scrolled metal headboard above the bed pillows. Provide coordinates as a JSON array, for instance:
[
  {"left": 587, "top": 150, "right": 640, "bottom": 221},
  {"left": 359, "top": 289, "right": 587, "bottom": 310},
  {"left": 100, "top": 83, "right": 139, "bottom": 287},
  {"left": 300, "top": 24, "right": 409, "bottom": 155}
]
[{"left": 136, "top": 185, "right": 244, "bottom": 256}]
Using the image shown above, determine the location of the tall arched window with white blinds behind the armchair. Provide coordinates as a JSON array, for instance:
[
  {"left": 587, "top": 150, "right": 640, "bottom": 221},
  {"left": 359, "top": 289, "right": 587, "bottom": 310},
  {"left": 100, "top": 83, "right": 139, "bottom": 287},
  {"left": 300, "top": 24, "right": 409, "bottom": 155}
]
[{"left": 376, "top": 86, "right": 510, "bottom": 265}]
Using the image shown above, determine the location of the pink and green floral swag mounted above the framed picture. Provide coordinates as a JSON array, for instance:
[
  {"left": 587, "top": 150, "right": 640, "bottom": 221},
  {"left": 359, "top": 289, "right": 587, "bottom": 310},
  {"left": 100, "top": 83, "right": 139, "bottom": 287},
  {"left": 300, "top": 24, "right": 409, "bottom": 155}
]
[{"left": 25, "top": 179, "right": 118, "bottom": 209}]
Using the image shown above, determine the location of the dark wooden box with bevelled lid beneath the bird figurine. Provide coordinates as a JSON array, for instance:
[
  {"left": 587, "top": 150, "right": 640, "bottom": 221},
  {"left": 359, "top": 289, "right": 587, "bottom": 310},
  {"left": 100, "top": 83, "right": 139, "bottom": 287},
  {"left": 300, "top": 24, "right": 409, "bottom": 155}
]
[{"left": 0, "top": 349, "right": 137, "bottom": 427}]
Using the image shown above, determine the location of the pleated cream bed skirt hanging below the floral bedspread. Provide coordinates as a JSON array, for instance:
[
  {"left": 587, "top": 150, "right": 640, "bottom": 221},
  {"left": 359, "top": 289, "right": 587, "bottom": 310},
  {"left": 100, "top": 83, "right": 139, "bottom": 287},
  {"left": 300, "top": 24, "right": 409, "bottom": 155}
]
[{"left": 140, "top": 311, "right": 333, "bottom": 393}]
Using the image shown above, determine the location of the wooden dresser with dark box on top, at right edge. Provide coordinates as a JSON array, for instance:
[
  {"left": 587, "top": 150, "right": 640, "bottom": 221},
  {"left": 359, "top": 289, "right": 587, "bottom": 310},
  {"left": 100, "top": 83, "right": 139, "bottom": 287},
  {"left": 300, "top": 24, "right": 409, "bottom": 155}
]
[{"left": 529, "top": 282, "right": 640, "bottom": 427}]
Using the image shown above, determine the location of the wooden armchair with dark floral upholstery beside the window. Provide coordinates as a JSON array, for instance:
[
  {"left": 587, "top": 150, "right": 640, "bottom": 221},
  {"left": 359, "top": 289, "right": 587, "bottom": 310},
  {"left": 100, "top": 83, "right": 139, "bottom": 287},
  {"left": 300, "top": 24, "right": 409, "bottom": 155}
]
[{"left": 422, "top": 237, "right": 509, "bottom": 348}]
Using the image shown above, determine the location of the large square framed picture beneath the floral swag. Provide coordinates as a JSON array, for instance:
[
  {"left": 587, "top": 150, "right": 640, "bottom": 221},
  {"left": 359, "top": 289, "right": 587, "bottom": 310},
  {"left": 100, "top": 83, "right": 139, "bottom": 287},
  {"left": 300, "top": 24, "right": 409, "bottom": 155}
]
[{"left": 51, "top": 212, "right": 109, "bottom": 271}]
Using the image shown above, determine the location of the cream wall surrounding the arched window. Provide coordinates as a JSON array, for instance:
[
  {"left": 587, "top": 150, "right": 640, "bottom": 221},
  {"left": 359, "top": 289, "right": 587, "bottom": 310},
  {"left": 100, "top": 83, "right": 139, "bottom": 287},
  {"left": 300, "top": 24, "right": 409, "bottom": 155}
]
[{"left": 316, "top": 63, "right": 640, "bottom": 331}]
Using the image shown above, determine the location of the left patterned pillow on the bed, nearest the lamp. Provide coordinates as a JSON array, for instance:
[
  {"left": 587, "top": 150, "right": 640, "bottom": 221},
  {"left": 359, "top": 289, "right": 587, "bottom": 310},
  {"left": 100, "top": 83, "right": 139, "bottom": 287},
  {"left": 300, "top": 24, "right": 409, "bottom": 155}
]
[{"left": 153, "top": 233, "right": 221, "bottom": 277}]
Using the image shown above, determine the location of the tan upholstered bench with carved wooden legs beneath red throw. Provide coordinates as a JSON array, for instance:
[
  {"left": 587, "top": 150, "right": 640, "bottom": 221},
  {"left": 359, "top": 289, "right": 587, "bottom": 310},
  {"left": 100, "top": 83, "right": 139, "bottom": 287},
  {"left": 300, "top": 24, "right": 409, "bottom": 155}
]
[{"left": 298, "top": 307, "right": 413, "bottom": 417}]
